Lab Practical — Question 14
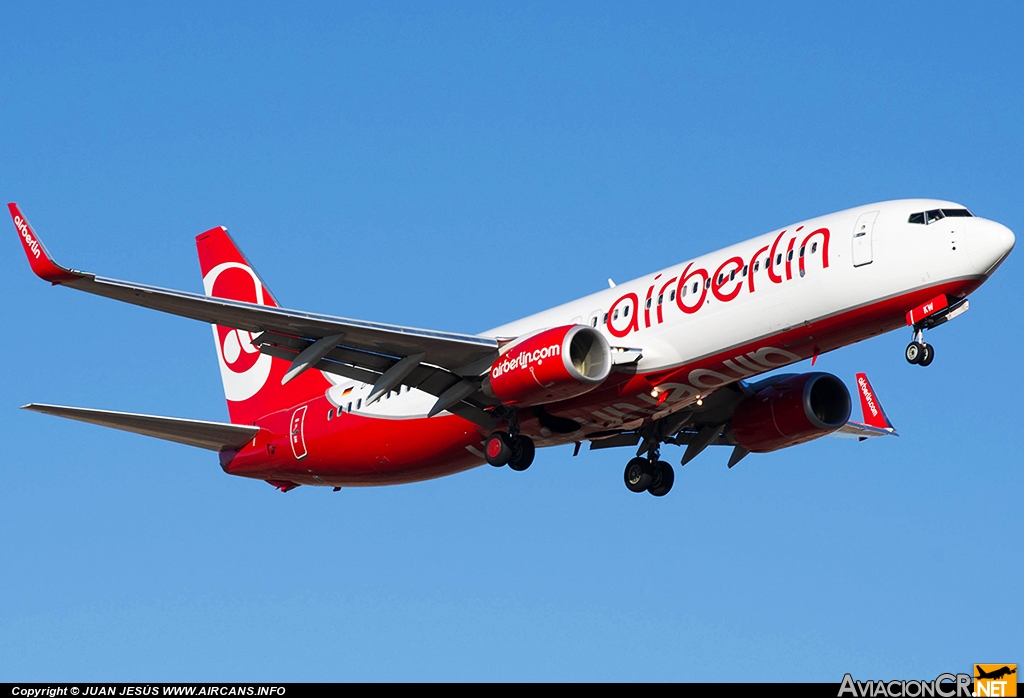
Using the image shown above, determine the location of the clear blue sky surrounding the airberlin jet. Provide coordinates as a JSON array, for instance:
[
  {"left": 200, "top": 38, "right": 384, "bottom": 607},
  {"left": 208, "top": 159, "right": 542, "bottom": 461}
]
[{"left": 0, "top": 2, "right": 1024, "bottom": 682}]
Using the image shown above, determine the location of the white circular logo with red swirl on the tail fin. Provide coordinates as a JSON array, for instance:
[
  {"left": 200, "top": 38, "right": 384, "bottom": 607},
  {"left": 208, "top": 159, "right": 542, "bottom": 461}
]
[{"left": 203, "top": 262, "right": 272, "bottom": 402}]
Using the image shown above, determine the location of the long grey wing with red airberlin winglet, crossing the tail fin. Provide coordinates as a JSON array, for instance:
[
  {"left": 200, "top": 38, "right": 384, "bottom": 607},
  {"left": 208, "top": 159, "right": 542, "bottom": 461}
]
[{"left": 8, "top": 204, "right": 499, "bottom": 384}]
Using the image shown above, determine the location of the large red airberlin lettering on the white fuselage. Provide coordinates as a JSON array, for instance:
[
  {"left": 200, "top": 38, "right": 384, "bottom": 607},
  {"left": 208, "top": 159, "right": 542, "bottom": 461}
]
[{"left": 606, "top": 226, "right": 830, "bottom": 338}]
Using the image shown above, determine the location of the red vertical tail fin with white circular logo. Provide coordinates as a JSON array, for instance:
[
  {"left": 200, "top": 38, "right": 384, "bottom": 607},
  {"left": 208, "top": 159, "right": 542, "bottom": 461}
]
[{"left": 196, "top": 227, "right": 331, "bottom": 424}]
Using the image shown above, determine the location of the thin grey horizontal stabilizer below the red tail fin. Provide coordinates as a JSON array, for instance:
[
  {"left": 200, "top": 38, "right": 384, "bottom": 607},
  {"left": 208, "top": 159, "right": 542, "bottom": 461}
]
[{"left": 22, "top": 403, "right": 259, "bottom": 451}]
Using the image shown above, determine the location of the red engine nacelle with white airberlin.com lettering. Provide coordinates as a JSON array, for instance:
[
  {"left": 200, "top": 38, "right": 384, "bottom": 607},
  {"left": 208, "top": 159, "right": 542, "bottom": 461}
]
[{"left": 483, "top": 324, "right": 611, "bottom": 407}]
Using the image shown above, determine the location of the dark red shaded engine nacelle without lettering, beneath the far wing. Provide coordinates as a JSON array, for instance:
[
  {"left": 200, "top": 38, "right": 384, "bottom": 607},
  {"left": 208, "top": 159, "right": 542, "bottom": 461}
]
[{"left": 732, "top": 374, "right": 850, "bottom": 453}]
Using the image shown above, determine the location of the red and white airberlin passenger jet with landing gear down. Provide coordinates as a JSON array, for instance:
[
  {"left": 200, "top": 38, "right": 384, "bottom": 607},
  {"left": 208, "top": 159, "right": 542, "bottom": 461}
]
[{"left": 8, "top": 200, "right": 1015, "bottom": 496}]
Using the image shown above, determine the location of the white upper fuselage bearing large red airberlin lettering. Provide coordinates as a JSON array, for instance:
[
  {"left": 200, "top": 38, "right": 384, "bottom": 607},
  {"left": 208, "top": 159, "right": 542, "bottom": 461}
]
[{"left": 330, "top": 199, "right": 1014, "bottom": 419}]
